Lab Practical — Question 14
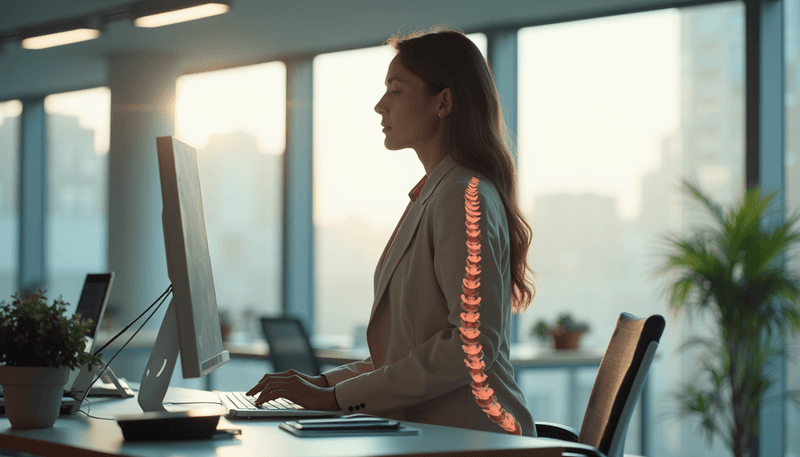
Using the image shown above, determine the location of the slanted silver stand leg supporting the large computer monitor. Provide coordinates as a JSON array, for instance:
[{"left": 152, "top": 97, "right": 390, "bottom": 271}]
[{"left": 139, "top": 298, "right": 179, "bottom": 412}]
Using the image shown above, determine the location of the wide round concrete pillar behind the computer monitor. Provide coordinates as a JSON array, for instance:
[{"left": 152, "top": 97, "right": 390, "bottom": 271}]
[{"left": 108, "top": 53, "right": 177, "bottom": 332}]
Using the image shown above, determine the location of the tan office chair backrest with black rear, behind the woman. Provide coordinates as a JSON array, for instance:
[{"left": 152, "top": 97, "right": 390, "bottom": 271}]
[{"left": 578, "top": 313, "right": 665, "bottom": 457}]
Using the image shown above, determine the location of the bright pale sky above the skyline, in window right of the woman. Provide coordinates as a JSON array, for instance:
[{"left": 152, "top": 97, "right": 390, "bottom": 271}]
[{"left": 518, "top": 10, "right": 680, "bottom": 219}]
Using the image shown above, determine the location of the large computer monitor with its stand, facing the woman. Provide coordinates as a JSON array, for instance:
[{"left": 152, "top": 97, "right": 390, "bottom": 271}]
[{"left": 139, "top": 136, "right": 230, "bottom": 412}]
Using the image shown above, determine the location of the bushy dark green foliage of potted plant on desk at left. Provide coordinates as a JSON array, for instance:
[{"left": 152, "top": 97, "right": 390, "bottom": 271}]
[{"left": 0, "top": 291, "right": 101, "bottom": 369}]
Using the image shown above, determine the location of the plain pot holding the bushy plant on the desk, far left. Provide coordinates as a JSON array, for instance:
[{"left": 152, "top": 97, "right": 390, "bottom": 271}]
[{"left": 0, "top": 366, "right": 69, "bottom": 428}]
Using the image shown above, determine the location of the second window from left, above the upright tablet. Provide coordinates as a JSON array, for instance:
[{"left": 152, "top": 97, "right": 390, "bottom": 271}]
[{"left": 44, "top": 87, "right": 111, "bottom": 306}]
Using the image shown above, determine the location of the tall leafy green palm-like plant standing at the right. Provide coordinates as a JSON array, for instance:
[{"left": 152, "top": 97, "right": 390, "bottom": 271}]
[{"left": 660, "top": 182, "right": 800, "bottom": 457}]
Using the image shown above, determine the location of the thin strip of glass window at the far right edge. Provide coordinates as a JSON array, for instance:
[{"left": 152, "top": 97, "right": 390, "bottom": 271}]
[{"left": 784, "top": 0, "right": 800, "bottom": 457}]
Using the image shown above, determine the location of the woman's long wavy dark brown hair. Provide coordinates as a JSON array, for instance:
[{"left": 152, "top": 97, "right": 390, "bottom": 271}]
[{"left": 387, "top": 29, "right": 536, "bottom": 311}]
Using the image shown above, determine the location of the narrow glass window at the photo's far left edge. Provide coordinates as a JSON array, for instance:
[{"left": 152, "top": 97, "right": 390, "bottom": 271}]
[{"left": 0, "top": 100, "right": 22, "bottom": 303}]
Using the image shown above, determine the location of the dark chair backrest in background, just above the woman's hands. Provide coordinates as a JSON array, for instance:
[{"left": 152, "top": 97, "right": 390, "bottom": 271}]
[{"left": 261, "top": 317, "right": 320, "bottom": 376}]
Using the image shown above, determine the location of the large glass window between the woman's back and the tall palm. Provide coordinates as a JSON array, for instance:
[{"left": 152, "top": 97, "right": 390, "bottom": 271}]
[{"left": 518, "top": 3, "right": 744, "bottom": 456}]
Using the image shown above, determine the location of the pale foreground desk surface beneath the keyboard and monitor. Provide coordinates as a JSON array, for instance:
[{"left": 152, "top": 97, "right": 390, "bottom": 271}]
[{"left": 0, "top": 387, "right": 591, "bottom": 457}]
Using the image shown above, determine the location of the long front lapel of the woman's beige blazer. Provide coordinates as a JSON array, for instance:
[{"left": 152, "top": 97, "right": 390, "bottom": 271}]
[{"left": 370, "top": 154, "right": 458, "bottom": 318}]
